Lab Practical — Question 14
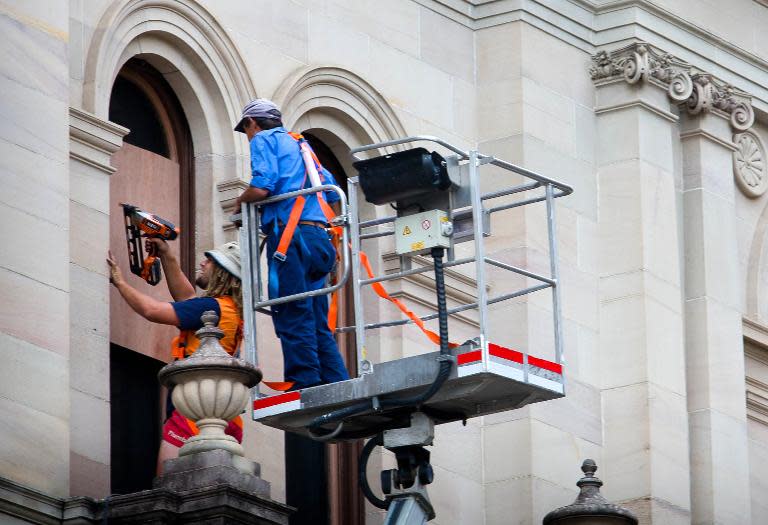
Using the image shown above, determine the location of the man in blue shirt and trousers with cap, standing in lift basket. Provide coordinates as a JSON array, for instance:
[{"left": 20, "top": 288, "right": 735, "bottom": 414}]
[{"left": 235, "top": 99, "right": 349, "bottom": 389}]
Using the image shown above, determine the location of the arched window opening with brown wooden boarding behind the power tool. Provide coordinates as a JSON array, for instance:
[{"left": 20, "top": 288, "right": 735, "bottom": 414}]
[{"left": 109, "top": 58, "right": 194, "bottom": 362}]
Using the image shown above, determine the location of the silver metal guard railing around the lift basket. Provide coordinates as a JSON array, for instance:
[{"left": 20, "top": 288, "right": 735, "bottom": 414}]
[{"left": 240, "top": 136, "right": 573, "bottom": 395}]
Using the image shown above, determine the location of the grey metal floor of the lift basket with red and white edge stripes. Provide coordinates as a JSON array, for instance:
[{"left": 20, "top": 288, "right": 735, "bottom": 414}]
[{"left": 253, "top": 344, "right": 565, "bottom": 439}]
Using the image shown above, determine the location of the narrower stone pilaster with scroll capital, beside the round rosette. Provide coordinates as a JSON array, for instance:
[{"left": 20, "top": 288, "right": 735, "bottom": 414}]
[{"left": 681, "top": 80, "right": 752, "bottom": 525}]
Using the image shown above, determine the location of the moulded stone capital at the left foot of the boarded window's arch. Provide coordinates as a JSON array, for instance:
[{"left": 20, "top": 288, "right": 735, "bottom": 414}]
[{"left": 69, "top": 107, "right": 130, "bottom": 174}]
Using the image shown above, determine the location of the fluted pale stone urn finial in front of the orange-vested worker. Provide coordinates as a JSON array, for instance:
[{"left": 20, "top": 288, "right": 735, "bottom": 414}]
[{"left": 157, "top": 311, "right": 261, "bottom": 456}]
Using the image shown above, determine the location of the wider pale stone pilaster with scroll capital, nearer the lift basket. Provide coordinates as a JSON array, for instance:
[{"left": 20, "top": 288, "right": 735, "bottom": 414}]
[{"left": 590, "top": 43, "right": 693, "bottom": 525}]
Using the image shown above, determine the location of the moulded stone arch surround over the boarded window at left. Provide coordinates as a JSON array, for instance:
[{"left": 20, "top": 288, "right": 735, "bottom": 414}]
[{"left": 82, "top": 0, "right": 256, "bottom": 254}]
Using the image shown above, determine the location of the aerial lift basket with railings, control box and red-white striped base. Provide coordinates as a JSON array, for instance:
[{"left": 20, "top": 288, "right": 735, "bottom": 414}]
[{"left": 234, "top": 136, "right": 573, "bottom": 524}]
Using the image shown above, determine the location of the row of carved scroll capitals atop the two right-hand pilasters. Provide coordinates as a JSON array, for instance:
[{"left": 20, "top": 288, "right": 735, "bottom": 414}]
[{"left": 589, "top": 42, "right": 755, "bottom": 131}]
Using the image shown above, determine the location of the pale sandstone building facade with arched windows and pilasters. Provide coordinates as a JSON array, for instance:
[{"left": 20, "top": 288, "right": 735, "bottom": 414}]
[{"left": 0, "top": 0, "right": 768, "bottom": 525}]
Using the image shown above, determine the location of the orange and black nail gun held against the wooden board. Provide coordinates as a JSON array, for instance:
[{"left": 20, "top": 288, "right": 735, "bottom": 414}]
[{"left": 120, "top": 203, "right": 180, "bottom": 286}]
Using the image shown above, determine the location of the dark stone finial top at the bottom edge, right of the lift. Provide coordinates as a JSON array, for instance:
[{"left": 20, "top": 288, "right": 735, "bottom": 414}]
[{"left": 542, "top": 459, "right": 637, "bottom": 525}]
